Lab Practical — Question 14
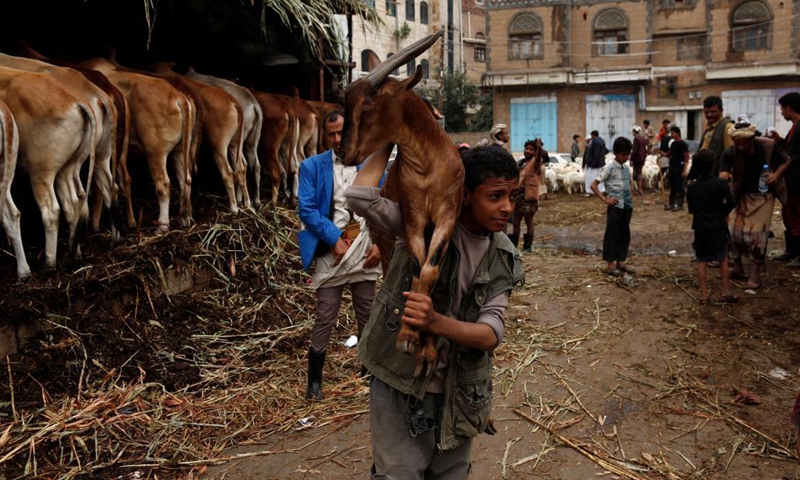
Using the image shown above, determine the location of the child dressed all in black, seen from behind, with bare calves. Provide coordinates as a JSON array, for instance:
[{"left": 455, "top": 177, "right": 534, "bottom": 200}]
[{"left": 686, "top": 149, "right": 739, "bottom": 304}]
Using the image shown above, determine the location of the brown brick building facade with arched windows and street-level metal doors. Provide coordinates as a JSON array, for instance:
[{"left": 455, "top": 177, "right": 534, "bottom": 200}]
[{"left": 484, "top": 0, "right": 800, "bottom": 151}]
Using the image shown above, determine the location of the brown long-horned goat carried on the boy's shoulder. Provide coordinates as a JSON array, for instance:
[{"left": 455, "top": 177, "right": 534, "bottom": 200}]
[{"left": 341, "top": 30, "right": 464, "bottom": 376}]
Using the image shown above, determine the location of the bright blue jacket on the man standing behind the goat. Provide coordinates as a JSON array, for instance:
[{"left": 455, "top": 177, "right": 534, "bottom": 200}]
[{"left": 297, "top": 150, "right": 385, "bottom": 270}]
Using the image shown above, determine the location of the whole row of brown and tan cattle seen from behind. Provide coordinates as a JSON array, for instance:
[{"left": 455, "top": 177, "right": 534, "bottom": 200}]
[{"left": 0, "top": 49, "right": 336, "bottom": 279}]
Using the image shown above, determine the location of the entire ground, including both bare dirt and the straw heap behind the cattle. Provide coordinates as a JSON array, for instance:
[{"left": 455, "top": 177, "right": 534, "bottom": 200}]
[{"left": 0, "top": 189, "right": 800, "bottom": 480}]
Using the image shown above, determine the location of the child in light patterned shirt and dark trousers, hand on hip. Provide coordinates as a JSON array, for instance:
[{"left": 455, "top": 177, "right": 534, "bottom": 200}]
[{"left": 591, "top": 137, "right": 636, "bottom": 277}]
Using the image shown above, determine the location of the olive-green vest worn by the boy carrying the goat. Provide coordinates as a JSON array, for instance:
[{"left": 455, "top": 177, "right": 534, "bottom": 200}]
[{"left": 358, "top": 229, "right": 525, "bottom": 450}]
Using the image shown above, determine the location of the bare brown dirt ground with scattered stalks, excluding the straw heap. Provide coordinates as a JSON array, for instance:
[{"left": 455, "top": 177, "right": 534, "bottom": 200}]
[{"left": 202, "top": 193, "right": 800, "bottom": 480}]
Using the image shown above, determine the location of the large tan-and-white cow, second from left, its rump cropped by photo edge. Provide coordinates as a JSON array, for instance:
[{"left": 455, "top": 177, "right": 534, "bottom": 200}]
[{"left": 0, "top": 67, "right": 97, "bottom": 268}]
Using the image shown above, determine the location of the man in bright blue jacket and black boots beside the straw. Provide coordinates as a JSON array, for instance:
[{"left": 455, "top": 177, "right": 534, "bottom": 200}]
[{"left": 298, "top": 111, "right": 381, "bottom": 400}]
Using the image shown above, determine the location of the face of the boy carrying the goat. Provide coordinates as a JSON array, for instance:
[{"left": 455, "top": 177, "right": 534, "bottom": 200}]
[{"left": 461, "top": 178, "right": 519, "bottom": 235}]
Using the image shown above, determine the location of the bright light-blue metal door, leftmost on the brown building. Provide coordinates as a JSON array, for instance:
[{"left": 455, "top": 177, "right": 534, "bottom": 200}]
[{"left": 509, "top": 96, "right": 558, "bottom": 152}]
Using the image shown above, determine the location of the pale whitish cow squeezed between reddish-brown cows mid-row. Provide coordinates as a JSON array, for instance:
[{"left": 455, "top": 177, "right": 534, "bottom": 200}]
[{"left": 185, "top": 68, "right": 264, "bottom": 208}]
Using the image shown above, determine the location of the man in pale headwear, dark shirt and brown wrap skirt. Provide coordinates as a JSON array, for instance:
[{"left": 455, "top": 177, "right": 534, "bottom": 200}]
[{"left": 719, "top": 122, "right": 791, "bottom": 289}]
